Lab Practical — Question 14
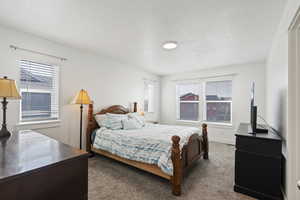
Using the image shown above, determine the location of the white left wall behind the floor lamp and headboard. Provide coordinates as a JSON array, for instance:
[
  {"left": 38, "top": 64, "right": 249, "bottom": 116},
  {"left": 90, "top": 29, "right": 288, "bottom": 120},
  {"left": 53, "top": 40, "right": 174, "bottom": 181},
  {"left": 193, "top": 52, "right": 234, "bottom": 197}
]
[{"left": 0, "top": 27, "right": 160, "bottom": 146}]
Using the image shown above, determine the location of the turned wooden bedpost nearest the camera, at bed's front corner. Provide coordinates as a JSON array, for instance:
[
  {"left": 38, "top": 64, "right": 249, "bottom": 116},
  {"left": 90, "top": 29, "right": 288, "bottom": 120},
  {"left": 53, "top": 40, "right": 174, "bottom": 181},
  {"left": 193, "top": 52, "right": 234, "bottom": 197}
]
[{"left": 171, "top": 135, "right": 182, "bottom": 196}]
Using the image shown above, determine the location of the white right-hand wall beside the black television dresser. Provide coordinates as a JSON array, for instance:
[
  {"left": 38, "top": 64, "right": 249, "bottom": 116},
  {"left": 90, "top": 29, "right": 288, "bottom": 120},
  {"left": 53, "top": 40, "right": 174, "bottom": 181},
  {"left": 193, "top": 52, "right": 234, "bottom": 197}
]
[{"left": 266, "top": 0, "right": 300, "bottom": 200}]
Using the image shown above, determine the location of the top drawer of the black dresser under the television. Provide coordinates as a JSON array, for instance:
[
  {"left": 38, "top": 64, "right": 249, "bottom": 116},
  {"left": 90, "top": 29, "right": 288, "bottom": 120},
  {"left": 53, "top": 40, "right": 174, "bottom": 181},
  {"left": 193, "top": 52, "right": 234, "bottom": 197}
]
[{"left": 236, "top": 136, "right": 282, "bottom": 157}]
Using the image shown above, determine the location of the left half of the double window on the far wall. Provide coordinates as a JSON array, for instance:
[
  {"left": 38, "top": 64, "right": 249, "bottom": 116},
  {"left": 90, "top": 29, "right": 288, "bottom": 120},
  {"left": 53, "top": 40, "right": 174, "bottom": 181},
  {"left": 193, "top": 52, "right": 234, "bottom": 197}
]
[{"left": 176, "top": 84, "right": 201, "bottom": 121}]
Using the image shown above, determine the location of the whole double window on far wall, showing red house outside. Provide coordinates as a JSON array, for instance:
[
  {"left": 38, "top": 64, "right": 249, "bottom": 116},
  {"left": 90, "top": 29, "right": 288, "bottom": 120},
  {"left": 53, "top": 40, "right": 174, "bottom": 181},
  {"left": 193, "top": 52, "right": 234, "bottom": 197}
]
[{"left": 176, "top": 79, "right": 232, "bottom": 124}]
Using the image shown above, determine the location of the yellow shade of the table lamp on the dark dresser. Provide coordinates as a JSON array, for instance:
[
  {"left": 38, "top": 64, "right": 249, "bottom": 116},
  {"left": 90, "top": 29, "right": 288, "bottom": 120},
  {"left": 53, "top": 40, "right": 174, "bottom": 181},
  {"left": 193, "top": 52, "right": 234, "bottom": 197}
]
[{"left": 0, "top": 77, "right": 21, "bottom": 99}]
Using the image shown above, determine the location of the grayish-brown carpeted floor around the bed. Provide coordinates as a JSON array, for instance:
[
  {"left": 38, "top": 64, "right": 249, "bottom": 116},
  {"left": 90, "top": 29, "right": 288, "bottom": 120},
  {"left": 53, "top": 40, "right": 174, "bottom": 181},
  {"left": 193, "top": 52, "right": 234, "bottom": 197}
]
[{"left": 89, "top": 143, "right": 252, "bottom": 200}]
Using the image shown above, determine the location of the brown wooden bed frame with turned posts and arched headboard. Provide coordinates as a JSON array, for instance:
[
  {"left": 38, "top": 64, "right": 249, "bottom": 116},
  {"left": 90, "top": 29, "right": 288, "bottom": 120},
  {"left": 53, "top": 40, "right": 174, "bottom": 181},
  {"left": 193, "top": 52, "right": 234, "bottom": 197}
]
[{"left": 86, "top": 103, "right": 208, "bottom": 196}]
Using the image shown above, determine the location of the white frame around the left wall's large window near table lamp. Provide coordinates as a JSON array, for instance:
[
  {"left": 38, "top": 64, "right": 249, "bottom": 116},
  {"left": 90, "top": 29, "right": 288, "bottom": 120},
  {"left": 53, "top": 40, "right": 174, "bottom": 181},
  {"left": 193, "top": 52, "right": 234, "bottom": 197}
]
[{"left": 18, "top": 59, "right": 61, "bottom": 123}]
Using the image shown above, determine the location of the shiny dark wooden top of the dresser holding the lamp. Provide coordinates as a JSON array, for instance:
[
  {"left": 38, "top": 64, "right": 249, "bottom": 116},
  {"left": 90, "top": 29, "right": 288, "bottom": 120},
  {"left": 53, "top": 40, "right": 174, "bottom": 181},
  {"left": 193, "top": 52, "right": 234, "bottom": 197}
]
[{"left": 0, "top": 131, "right": 89, "bottom": 182}]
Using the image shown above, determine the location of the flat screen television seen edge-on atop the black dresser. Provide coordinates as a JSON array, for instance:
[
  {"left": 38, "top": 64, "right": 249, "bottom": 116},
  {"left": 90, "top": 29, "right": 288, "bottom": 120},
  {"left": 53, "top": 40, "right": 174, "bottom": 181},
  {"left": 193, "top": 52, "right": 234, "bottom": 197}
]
[{"left": 250, "top": 82, "right": 268, "bottom": 134}]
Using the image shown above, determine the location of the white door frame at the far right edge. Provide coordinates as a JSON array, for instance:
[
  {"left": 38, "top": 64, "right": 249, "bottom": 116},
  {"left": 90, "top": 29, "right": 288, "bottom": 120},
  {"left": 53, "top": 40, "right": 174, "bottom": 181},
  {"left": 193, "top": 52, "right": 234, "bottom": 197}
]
[{"left": 287, "top": 11, "right": 300, "bottom": 199}]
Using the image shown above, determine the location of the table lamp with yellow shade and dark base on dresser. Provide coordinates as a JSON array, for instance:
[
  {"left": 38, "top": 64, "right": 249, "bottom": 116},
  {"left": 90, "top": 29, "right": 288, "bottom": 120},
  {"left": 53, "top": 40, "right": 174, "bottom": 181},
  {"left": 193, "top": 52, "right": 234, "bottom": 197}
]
[{"left": 0, "top": 76, "right": 21, "bottom": 138}]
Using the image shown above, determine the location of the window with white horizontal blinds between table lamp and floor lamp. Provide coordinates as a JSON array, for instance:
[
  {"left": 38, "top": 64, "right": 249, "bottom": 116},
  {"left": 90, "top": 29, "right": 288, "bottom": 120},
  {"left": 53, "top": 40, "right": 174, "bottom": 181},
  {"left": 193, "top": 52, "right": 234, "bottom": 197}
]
[{"left": 19, "top": 60, "right": 59, "bottom": 122}]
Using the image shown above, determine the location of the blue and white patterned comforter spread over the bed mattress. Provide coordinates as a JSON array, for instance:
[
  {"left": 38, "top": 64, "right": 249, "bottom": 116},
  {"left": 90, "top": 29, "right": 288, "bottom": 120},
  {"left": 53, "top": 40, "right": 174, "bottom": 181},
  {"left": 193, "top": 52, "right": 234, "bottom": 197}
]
[{"left": 92, "top": 124, "right": 202, "bottom": 175}]
